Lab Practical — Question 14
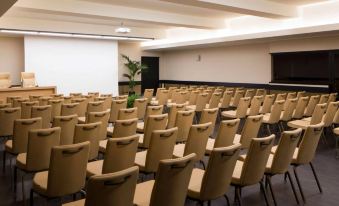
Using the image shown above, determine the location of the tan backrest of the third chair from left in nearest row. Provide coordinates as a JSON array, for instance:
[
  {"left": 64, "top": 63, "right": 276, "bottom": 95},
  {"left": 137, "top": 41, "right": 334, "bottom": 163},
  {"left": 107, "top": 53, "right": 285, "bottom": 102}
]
[{"left": 200, "top": 144, "right": 240, "bottom": 200}]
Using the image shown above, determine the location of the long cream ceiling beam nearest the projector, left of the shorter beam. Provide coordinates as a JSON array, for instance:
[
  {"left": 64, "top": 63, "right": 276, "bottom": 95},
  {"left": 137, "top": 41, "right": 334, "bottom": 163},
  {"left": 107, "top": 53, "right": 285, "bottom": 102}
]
[{"left": 15, "top": 0, "right": 226, "bottom": 29}]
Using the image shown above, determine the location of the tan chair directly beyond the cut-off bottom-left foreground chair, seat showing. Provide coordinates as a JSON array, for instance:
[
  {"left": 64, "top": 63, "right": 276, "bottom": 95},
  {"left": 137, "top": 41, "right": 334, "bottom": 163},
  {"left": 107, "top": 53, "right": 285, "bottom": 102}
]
[{"left": 87, "top": 135, "right": 139, "bottom": 178}]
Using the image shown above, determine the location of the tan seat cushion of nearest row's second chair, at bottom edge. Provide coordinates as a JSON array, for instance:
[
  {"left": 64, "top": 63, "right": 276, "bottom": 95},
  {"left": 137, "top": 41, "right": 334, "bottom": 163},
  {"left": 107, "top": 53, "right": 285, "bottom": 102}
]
[{"left": 133, "top": 180, "right": 155, "bottom": 206}]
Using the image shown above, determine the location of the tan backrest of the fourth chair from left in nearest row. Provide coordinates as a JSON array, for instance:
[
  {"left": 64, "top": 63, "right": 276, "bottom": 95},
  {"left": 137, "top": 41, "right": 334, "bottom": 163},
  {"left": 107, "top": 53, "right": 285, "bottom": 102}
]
[{"left": 240, "top": 135, "right": 275, "bottom": 186}]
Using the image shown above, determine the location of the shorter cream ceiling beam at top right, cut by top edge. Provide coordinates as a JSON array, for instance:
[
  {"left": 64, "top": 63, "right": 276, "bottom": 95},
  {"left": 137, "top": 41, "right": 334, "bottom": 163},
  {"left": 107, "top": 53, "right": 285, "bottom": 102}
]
[{"left": 161, "top": 0, "right": 298, "bottom": 18}]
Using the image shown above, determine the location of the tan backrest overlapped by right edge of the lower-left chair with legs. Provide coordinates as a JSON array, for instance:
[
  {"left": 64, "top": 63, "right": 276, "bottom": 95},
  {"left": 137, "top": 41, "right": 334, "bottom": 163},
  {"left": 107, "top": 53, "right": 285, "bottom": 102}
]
[{"left": 73, "top": 122, "right": 101, "bottom": 160}]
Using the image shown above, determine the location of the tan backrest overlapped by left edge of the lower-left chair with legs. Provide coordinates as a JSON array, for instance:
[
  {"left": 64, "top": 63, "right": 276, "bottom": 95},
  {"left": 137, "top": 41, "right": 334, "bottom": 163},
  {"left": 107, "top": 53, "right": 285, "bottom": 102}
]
[{"left": 26, "top": 127, "right": 61, "bottom": 171}]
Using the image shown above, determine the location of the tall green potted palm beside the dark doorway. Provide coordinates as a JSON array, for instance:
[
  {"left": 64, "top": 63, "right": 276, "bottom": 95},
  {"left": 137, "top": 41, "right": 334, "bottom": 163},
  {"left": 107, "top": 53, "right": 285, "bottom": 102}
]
[{"left": 121, "top": 54, "right": 148, "bottom": 95}]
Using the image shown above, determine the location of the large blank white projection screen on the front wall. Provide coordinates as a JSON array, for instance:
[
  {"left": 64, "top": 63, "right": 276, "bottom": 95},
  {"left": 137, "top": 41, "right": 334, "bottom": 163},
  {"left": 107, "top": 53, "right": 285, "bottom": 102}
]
[{"left": 25, "top": 36, "right": 118, "bottom": 95}]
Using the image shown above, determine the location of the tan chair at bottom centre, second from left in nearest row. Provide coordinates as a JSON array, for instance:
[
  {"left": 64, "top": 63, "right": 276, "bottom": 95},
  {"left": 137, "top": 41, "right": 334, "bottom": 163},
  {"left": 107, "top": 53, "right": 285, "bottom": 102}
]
[{"left": 133, "top": 154, "right": 195, "bottom": 206}]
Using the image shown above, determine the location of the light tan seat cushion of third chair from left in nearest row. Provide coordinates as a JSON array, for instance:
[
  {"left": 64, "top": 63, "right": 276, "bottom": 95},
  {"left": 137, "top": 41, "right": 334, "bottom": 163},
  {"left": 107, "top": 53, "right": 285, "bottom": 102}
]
[{"left": 187, "top": 168, "right": 205, "bottom": 200}]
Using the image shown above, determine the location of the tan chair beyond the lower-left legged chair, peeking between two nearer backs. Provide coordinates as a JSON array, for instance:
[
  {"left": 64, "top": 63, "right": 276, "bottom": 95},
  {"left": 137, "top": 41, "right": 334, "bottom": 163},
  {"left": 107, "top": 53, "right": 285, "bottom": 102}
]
[{"left": 52, "top": 114, "right": 78, "bottom": 145}]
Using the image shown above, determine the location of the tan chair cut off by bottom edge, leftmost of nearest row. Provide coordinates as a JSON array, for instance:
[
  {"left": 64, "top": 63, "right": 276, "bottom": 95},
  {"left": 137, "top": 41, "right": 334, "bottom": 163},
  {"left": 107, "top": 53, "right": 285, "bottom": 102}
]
[{"left": 63, "top": 167, "right": 139, "bottom": 206}]
